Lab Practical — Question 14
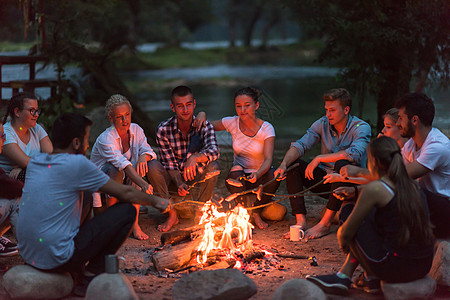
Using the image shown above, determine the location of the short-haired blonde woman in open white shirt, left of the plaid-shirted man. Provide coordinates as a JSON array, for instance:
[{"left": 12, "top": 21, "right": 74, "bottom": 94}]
[{"left": 91, "top": 95, "right": 156, "bottom": 240}]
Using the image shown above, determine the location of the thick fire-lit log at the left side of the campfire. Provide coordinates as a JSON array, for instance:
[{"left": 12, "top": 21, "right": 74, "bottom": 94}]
[{"left": 152, "top": 239, "right": 201, "bottom": 271}]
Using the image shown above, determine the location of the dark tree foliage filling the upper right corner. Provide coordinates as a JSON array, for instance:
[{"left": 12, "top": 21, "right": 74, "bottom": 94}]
[{"left": 286, "top": 0, "right": 450, "bottom": 127}]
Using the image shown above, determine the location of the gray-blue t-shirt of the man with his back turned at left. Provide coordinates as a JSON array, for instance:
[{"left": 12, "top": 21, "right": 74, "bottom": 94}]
[{"left": 17, "top": 153, "right": 109, "bottom": 270}]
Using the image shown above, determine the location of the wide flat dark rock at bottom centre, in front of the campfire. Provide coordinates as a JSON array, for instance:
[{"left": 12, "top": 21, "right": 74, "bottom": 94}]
[{"left": 172, "top": 269, "right": 257, "bottom": 300}]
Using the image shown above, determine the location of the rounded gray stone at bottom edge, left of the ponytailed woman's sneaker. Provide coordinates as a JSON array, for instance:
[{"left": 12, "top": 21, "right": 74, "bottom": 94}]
[{"left": 272, "top": 279, "right": 327, "bottom": 300}]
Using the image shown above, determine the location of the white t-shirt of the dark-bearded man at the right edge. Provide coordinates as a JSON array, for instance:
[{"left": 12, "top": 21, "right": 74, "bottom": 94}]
[{"left": 402, "top": 128, "right": 450, "bottom": 197}]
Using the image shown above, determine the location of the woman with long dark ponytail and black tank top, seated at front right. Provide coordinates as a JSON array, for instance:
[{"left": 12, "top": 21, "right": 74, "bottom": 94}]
[{"left": 307, "top": 137, "right": 434, "bottom": 294}]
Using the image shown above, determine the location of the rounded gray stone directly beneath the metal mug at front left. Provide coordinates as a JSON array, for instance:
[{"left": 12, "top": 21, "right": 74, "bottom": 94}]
[{"left": 86, "top": 273, "right": 139, "bottom": 300}]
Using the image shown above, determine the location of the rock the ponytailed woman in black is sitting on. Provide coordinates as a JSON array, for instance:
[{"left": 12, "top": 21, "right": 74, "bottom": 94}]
[{"left": 381, "top": 275, "right": 436, "bottom": 300}]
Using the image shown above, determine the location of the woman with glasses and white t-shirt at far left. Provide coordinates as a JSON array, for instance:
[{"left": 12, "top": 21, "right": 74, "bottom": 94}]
[{"left": 0, "top": 92, "right": 53, "bottom": 181}]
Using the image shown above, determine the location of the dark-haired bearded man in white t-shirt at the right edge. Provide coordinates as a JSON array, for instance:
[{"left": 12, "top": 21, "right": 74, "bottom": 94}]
[{"left": 395, "top": 93, "right": 450, "bottom": 237}]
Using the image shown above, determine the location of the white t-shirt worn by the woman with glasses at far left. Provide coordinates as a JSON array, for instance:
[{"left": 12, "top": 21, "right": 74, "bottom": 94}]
[{"left": 0, "top": 121, "right": 47, "bottom": 174}]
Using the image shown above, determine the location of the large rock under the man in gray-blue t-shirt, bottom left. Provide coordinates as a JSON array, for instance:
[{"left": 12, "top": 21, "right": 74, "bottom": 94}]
[{"left": 3, "top": 265, "right": 73, "bottom": 299}]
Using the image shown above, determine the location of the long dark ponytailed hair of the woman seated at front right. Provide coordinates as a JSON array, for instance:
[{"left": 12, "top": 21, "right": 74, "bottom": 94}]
[{"left": 369, "top": 136, "right": 432, "bottom": 245}]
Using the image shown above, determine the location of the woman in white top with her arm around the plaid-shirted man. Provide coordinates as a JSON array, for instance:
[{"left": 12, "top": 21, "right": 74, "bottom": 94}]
[{"left": 197, "top": 87, "right": 280, "bottom": 229}]
